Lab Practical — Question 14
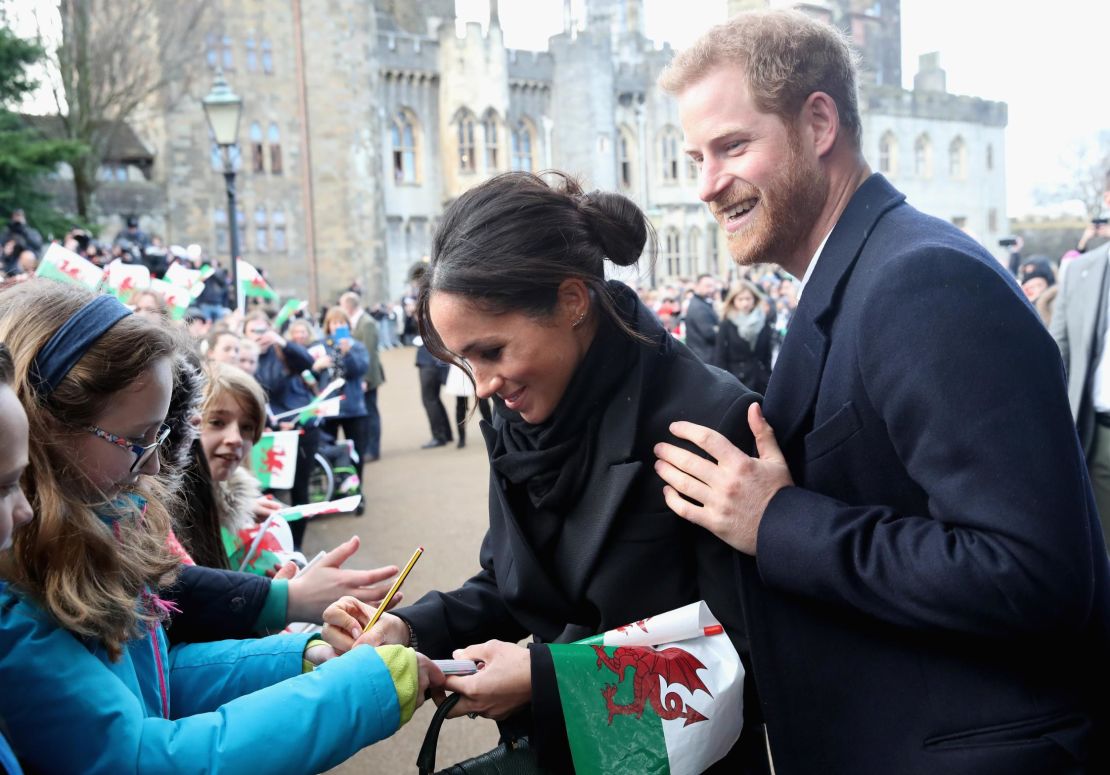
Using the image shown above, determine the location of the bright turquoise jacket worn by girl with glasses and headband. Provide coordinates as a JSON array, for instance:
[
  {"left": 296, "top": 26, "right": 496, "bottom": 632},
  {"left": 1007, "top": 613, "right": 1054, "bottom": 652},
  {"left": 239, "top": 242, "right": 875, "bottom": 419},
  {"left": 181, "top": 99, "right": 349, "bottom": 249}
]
[{"left": 0, "top": 595, "right": 401, "bottom": 775}]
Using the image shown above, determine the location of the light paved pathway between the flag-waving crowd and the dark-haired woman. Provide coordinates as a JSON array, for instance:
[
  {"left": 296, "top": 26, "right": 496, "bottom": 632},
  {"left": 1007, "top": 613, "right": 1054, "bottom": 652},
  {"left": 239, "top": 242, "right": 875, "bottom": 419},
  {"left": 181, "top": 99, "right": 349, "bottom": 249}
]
[{"left": 299, "top": 348, "right": 497, "bottom": 775}]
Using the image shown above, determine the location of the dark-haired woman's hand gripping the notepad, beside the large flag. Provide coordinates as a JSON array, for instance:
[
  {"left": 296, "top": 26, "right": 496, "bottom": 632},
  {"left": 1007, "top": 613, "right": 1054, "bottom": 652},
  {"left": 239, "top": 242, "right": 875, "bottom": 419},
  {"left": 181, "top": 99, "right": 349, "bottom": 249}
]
[{"left": 440, "top": 641, "right": 532, "bottom": 721}]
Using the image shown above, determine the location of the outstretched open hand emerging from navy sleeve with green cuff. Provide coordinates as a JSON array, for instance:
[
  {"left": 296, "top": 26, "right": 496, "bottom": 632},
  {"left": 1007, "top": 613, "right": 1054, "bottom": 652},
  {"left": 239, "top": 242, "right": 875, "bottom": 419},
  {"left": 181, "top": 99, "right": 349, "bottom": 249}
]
[{"left": 287, "top": 536, "right": 401, "bottom": 623}]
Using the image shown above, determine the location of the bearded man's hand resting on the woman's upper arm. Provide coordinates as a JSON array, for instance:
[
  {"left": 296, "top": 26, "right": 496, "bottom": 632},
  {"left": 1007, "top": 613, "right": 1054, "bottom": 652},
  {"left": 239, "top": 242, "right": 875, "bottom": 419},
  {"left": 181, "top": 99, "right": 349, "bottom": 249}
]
[{"left": 655, "top": 404, "right": 794, "bottom": 556}]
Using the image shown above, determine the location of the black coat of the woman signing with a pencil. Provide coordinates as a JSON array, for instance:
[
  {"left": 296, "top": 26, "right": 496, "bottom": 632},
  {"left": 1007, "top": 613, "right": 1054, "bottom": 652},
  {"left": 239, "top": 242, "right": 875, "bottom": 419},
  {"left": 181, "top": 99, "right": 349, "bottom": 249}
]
[{"left": 396, "top": 304, "right": 758, "bottom": 772}]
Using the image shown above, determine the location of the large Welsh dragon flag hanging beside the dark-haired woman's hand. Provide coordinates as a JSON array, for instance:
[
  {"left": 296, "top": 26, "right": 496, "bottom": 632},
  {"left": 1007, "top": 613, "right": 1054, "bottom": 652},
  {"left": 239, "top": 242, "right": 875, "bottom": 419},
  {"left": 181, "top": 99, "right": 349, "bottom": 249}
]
[{"left": 549, "top": 602, "right": 744, "bottom": 775}]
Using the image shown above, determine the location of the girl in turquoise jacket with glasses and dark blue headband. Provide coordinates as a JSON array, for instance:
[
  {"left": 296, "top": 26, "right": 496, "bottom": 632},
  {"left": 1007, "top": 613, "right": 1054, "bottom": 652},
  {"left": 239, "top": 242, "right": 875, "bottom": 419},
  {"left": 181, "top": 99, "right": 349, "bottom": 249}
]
[{"left": 0, "top": 280, "right": 442, "bottom": 773}]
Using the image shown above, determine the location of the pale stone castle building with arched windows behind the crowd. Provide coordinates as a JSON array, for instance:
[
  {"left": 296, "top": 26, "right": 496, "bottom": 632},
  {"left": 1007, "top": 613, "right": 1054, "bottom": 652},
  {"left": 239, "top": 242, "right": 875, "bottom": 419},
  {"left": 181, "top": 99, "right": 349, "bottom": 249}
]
[{"left": 119, "top": 0, "right": 1007, "bottom": 302}]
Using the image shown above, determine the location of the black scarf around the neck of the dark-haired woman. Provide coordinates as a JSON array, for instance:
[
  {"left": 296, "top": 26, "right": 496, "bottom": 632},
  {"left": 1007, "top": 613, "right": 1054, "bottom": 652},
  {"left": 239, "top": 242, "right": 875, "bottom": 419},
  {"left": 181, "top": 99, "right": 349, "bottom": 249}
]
[{"left": 490, "top": 281, "right": 639, "bottom": 551}]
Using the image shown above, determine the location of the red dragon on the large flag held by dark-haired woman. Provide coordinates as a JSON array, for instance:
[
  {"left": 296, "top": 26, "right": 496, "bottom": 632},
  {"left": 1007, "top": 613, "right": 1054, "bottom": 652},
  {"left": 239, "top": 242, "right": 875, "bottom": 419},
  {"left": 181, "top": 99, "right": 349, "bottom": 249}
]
[{"left": 594, "top": 646, "right": 713, "bottom": 726}]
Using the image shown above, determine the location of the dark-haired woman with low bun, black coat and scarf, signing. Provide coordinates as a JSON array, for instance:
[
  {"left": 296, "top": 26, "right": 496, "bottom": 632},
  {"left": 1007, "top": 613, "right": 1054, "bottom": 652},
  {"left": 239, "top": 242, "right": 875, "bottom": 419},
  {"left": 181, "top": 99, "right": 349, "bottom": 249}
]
[{"left": 324, "top": 173, "right": 757, "bottom": 772}]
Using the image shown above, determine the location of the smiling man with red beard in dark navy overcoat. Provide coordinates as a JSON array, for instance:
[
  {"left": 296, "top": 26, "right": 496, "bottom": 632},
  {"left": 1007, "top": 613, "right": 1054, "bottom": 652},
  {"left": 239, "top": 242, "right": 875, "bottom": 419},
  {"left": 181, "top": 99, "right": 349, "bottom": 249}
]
[{"left": 656, "top": 11, "right": 1110, "bottom": 775}]
